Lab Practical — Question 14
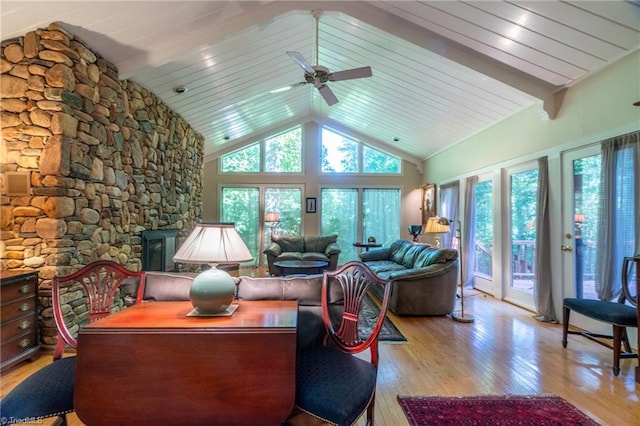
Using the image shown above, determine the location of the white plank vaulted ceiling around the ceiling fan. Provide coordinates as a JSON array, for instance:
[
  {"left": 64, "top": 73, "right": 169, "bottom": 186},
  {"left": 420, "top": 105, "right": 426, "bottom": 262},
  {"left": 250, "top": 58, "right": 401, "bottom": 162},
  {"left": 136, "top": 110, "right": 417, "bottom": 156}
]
[{"left": 0, "top": 0, "right": 640, "bottom": 162}]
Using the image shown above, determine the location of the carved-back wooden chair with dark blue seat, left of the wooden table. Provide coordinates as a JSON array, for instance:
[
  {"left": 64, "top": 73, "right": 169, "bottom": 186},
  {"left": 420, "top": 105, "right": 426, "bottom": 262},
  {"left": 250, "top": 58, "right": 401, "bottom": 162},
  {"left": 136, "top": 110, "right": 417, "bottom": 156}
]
[{"left": 0, "top": 260, "right": 145, "bottom": 425}]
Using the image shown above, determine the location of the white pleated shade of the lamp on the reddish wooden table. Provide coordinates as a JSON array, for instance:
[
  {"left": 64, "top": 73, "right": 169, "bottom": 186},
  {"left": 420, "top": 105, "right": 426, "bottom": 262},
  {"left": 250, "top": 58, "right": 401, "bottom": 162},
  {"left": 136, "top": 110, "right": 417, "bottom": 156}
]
[{"left": 173, "top": 223, "right": 253, "bottom": 263}]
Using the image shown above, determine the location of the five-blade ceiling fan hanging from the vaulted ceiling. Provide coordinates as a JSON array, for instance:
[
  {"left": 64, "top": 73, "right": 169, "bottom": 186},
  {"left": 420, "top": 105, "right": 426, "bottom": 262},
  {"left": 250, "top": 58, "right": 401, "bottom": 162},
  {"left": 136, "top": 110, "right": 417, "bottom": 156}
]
[{"left": 287, "top": 10, "right": 372, "bottom": 106}]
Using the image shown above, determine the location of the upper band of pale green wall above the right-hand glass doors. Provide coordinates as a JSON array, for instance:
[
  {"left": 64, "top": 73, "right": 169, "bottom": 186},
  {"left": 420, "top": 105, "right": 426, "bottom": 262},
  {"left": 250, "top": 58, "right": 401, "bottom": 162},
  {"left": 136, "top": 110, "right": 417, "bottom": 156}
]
[{"left": 424, "top": 52, "right": 640, "bottom": 182}]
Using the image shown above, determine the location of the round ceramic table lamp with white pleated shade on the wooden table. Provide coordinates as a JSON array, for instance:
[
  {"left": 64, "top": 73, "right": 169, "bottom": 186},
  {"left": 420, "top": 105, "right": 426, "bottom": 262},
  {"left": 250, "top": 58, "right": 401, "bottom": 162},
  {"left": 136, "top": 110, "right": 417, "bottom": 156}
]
[{"left": 173, "top": 223, "right": 253, "bottom": 316}]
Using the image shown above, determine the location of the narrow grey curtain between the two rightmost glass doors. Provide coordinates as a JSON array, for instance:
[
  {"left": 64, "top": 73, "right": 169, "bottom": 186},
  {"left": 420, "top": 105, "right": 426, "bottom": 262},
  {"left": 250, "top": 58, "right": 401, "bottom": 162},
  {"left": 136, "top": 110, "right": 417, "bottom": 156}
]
[{"left": 533, "top": 157, "right": 558, "bottom": 322}]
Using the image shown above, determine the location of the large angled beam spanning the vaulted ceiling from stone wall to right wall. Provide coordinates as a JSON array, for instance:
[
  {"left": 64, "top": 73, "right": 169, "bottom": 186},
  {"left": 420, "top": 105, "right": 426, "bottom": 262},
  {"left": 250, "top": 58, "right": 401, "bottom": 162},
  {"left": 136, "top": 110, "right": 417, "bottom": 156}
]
[{"left": 116, "top": 1, "right": 563, "bottom": 119}]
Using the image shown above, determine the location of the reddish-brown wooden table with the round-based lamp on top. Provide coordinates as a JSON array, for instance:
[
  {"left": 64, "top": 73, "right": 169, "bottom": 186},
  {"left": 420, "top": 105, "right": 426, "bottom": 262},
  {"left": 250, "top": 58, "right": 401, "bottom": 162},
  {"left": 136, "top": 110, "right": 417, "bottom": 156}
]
[{"left": 74, "top": 301, "right": 298, "bottom": 426}]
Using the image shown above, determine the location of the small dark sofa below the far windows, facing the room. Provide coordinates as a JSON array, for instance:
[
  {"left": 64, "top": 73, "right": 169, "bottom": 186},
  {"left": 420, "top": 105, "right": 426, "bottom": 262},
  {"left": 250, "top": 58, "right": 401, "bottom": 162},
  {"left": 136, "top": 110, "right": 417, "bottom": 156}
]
[{"left": 264, "top": 235, "right": 340, "bottom": 276}]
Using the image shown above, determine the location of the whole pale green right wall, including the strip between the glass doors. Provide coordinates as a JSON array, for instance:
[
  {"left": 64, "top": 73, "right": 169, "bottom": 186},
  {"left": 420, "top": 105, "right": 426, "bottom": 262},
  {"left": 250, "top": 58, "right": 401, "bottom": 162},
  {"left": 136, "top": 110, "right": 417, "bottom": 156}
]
[{"left": 424, "top": 52, "right": 640, "bottom": 342}]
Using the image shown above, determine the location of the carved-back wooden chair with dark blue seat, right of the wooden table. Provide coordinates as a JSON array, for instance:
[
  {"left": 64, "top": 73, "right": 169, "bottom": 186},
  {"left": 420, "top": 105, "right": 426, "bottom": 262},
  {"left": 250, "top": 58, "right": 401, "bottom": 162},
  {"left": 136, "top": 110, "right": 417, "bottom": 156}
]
[{"left": 296, "top": 262, "right": 391, "bottom": 425}]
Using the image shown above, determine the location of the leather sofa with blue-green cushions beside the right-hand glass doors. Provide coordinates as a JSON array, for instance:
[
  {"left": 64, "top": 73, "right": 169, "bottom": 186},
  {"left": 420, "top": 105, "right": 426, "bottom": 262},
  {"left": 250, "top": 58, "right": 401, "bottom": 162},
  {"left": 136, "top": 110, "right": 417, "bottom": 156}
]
[{"left": 360, "top": 240, "right": 459, "bottom": 315}]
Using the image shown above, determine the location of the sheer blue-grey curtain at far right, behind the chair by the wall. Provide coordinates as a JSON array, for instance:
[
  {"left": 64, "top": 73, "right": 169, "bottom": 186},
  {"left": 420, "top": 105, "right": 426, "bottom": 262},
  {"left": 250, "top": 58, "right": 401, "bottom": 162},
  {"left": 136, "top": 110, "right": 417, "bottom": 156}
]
[{"left": 595, "top": 132, "right": 640, "bottom": 301}]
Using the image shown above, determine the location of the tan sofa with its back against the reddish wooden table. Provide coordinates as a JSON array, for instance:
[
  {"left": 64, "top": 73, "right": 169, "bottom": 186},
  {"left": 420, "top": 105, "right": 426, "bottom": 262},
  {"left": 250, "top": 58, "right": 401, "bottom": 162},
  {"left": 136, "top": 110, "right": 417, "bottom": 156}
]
[{"left": 120, "top": 271, "right": 343, "bottom": 349}]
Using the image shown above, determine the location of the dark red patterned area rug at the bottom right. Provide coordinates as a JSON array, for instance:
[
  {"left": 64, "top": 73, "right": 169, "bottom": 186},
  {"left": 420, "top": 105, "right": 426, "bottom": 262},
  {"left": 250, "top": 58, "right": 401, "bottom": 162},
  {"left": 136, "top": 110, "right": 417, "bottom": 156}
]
[{"left": 398, "top": 395, "right": 598, "bottom": 426}]
